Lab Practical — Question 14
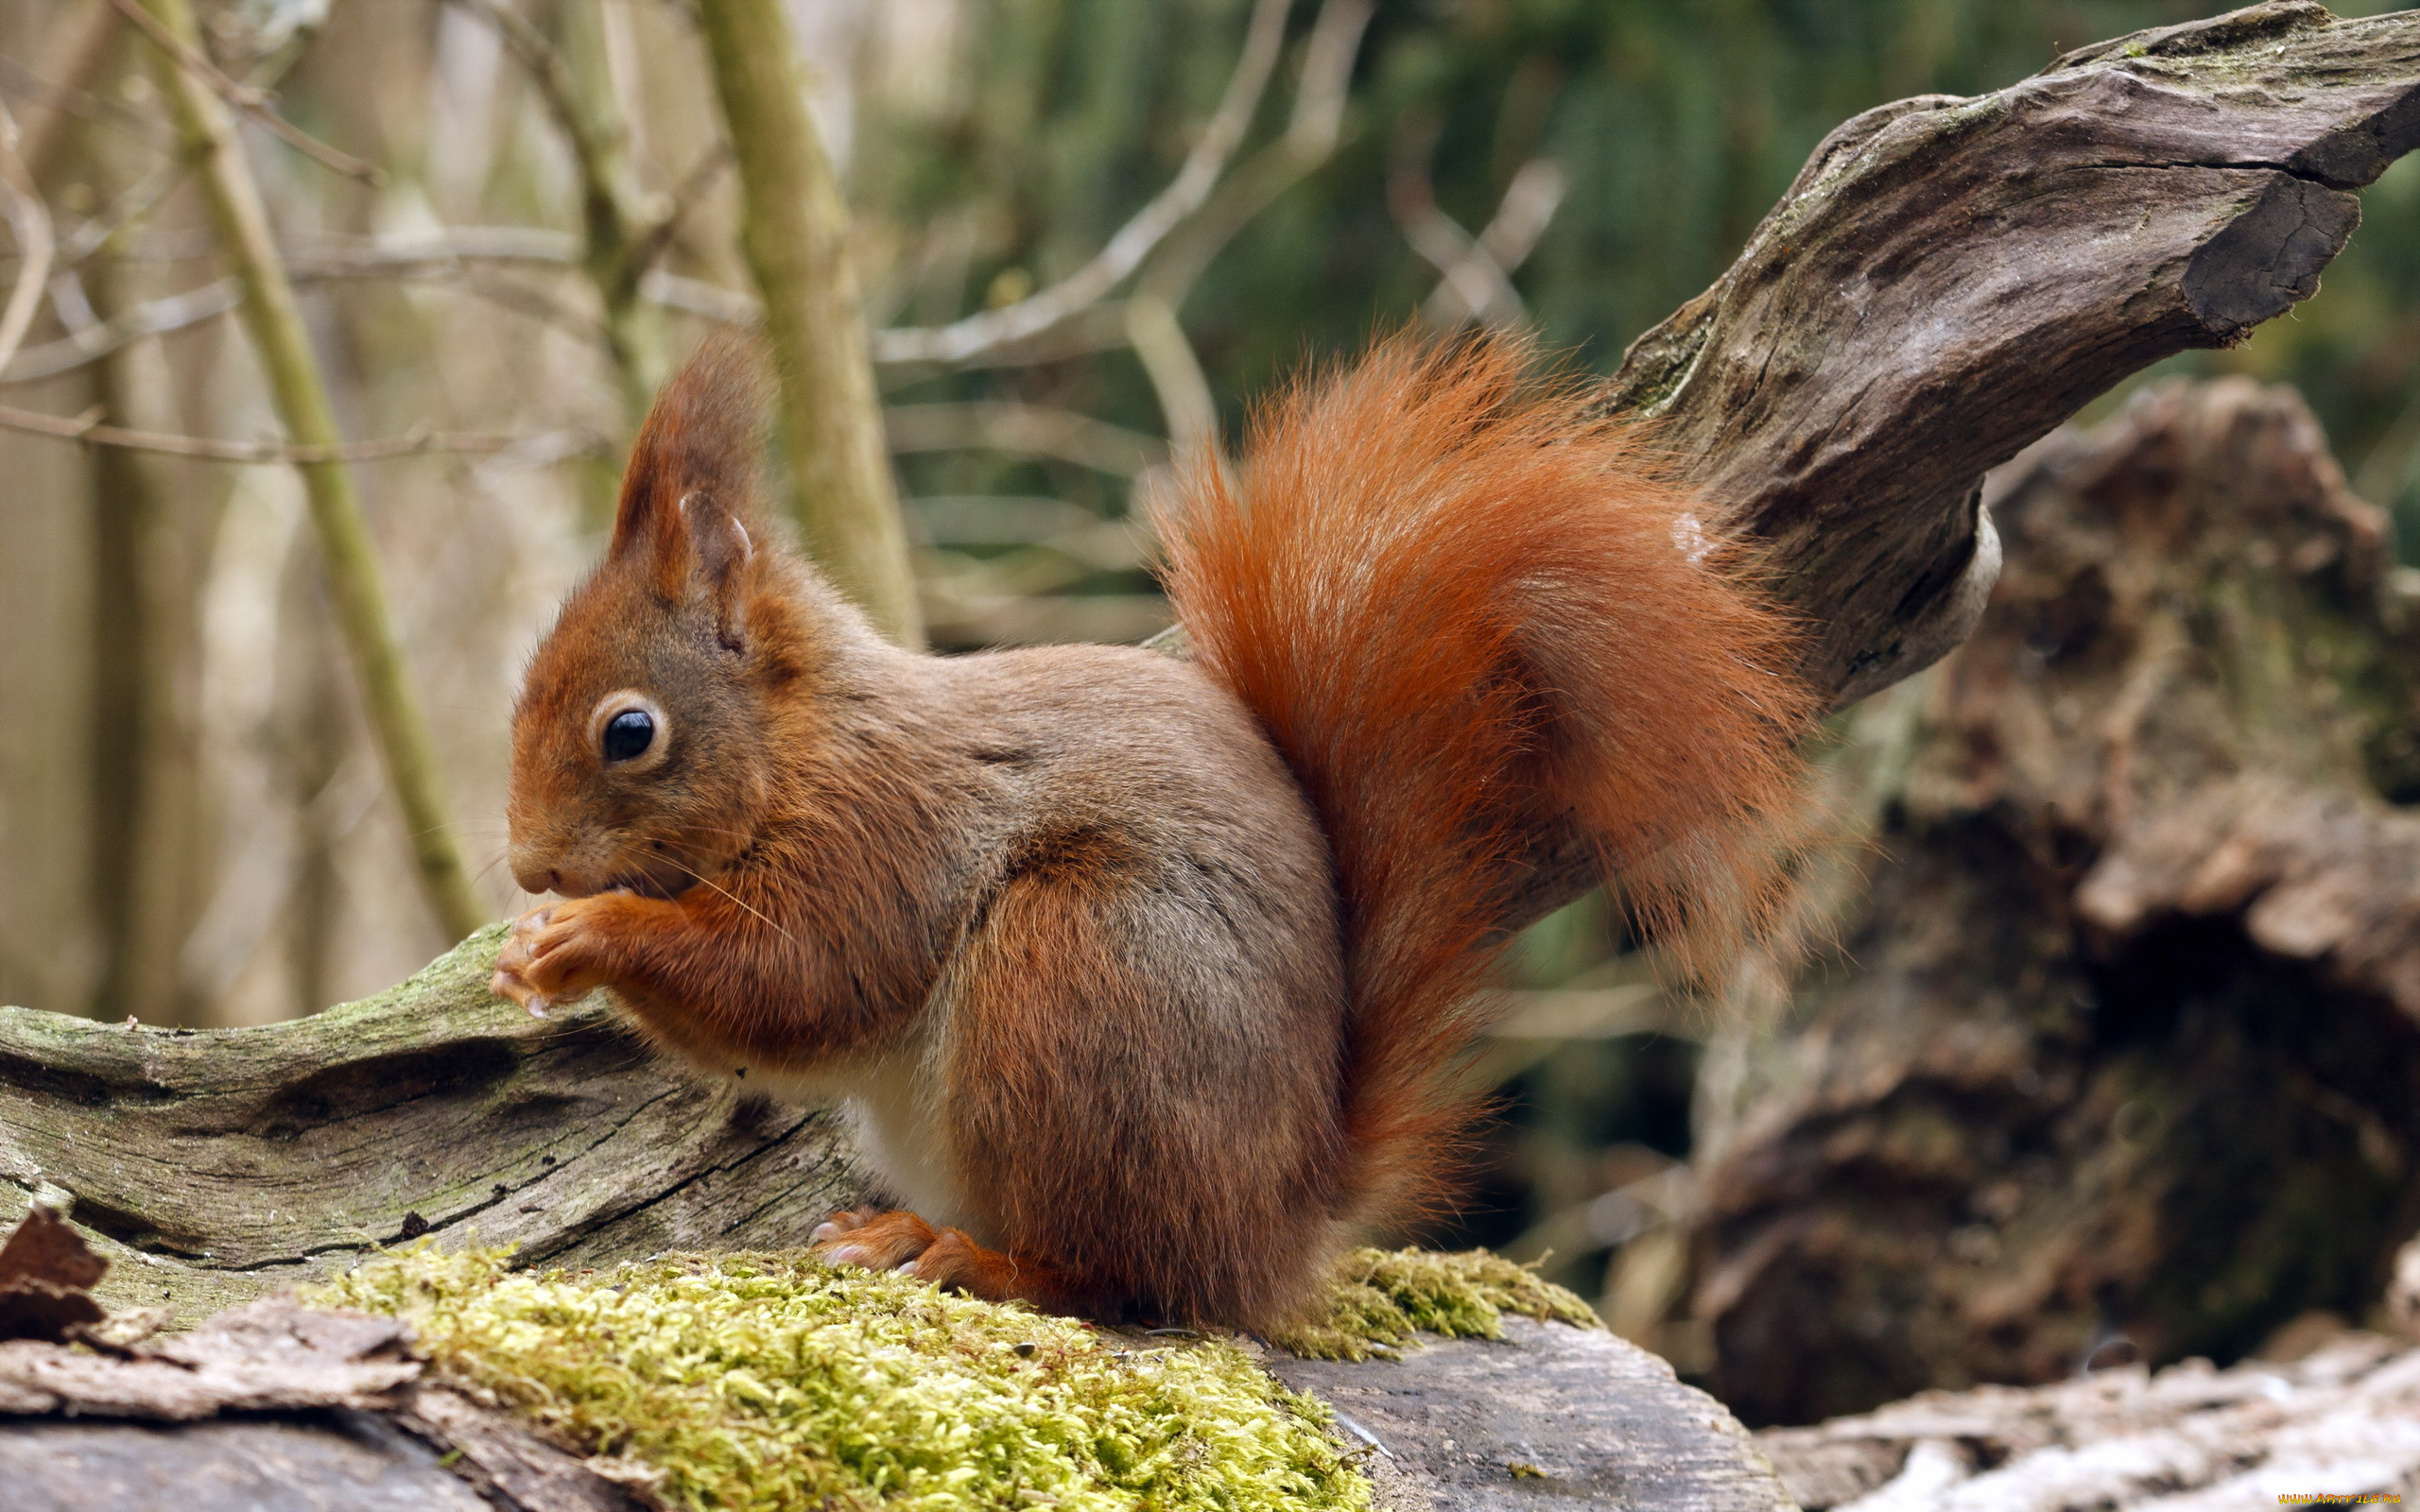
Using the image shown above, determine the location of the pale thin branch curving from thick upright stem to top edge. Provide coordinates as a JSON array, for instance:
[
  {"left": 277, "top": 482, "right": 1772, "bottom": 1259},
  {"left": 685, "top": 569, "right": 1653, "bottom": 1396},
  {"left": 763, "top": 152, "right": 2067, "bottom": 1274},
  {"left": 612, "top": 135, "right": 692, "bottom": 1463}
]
[{"left": 873, "top": 0, "right": 1289, "bottom": 363}]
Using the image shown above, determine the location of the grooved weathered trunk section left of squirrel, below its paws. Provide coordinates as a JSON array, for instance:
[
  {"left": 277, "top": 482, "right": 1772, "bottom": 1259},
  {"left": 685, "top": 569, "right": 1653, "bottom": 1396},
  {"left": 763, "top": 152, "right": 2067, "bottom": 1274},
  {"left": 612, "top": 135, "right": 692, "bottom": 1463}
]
[{"left": 0, "top": 926, "right": 856, "bottom": 1318}]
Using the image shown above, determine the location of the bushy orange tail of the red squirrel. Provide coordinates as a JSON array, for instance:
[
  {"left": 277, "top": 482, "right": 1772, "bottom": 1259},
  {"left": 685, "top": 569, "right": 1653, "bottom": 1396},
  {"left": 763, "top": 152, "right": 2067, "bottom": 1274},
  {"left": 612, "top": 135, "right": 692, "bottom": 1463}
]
[{"left": 1159, "top": 336, "right": 1815, "bottom": 1222}]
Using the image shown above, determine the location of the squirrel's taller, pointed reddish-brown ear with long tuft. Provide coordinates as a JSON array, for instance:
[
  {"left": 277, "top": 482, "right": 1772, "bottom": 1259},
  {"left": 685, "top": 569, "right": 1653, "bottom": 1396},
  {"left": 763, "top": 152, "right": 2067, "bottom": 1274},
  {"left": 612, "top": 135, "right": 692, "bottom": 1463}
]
[{"left": 610, "top": 334, "right": 765, "bottom": 577}]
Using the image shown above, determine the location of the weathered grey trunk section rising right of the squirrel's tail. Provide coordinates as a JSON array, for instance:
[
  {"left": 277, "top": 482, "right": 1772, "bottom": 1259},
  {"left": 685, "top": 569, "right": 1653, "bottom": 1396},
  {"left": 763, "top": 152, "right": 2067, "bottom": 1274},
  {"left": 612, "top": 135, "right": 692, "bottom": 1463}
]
[{"left": 1609, "top": 5, "right": 2420, "bottom": 704}]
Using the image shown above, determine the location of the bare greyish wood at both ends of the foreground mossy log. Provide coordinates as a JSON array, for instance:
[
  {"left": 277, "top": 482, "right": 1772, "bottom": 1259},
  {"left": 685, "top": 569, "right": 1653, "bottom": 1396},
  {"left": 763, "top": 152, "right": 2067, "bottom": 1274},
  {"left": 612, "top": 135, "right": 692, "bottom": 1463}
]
[{"left": 0, "top": 1299, "right": 1789, "bottom": 1512}]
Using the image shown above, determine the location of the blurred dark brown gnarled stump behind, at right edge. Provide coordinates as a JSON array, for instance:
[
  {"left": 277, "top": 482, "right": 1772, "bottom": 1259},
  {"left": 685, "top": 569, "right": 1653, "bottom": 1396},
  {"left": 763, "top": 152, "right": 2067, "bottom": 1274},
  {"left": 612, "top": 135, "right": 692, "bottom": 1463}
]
[{"left": 1694, "top": 380, "right": 2420, "bottom": 1422}]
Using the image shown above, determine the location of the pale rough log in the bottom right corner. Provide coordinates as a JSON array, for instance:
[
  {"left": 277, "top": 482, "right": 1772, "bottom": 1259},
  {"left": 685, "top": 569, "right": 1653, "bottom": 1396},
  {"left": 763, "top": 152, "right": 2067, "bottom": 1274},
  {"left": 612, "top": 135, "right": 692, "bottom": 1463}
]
[{"left": 1757, "top": 1333, "right": 2420, "bottom": 1512}]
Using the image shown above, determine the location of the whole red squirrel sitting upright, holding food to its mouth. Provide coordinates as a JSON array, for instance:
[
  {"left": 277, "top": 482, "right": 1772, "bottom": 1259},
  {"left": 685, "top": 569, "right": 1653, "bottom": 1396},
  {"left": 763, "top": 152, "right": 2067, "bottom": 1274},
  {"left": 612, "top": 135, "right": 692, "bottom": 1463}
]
[{"left": 493, "top": 326, "right": 1815, "bottom": 1328}]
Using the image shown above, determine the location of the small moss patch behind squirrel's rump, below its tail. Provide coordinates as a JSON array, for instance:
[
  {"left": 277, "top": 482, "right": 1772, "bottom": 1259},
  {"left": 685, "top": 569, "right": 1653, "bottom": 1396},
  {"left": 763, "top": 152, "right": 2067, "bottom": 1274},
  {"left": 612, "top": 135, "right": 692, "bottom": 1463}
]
[{"left": 1270, "top": 1248, "right": 1602, "bottom": 1360}]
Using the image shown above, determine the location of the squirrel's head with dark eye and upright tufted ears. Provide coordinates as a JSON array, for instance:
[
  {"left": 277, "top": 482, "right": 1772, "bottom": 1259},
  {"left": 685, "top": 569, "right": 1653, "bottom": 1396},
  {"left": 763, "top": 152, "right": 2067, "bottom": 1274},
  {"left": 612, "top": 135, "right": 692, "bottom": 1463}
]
[{"left": 506, "top": 341, "right": 799, "bottom": 898}]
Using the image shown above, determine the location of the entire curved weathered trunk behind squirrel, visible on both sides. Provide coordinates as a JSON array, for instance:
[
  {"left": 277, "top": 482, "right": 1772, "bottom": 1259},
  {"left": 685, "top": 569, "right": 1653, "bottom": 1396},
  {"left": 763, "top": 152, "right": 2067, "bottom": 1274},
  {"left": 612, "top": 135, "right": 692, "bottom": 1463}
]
[{"left": 0, "top": 5, "right": 2420, "bottom": 1461}]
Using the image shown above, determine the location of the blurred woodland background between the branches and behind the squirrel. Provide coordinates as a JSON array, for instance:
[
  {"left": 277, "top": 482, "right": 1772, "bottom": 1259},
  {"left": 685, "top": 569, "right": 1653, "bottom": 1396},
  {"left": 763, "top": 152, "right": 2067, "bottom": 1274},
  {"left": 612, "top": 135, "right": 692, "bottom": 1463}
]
[{"left": 0, "top": 0, "right": 2420, "bottom": 1364}]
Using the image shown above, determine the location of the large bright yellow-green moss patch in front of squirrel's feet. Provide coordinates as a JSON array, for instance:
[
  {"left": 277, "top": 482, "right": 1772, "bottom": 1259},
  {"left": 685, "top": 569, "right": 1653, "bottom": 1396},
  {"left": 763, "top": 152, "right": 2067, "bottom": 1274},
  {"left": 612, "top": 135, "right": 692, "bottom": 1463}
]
[{"left": 315, "top": 1244, "right": 1370, "bottom": 1512}]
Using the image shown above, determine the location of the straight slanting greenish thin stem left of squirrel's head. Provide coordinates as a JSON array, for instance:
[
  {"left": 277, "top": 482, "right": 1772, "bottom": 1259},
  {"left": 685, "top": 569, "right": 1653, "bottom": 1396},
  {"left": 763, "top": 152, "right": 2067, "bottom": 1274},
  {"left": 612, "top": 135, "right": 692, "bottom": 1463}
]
[{"left": 146, "top": 0, "right": 487, "bottom": 938}]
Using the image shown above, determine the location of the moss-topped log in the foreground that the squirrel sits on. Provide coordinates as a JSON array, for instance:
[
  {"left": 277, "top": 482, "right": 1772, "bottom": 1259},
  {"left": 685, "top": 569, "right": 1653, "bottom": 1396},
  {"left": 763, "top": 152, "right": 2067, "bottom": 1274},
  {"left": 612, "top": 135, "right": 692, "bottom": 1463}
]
[{"left": 0, "top": 1207, "right": 1784, "bottom": 1512}]
